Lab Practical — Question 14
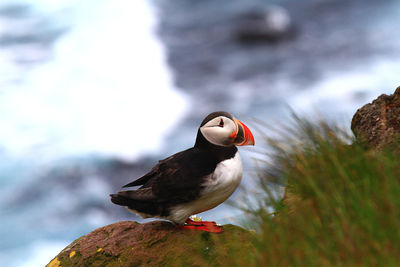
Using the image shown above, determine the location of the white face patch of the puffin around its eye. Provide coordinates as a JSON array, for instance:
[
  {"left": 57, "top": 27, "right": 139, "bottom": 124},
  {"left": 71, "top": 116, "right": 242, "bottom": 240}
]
[{"left": 200, "top": 116, "right": 236, "bottom": 146}]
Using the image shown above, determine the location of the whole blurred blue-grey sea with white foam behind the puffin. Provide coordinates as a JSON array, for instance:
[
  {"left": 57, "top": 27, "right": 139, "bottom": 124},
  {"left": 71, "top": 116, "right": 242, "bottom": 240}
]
[{"left": 0, "top": 0, "right": 400, "bottom": 266}]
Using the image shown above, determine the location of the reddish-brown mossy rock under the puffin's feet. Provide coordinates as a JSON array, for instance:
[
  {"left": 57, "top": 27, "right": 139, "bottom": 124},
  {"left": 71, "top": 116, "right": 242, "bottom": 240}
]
[{"left": 47, "top": 221, "right": 252, "bottom": 267}]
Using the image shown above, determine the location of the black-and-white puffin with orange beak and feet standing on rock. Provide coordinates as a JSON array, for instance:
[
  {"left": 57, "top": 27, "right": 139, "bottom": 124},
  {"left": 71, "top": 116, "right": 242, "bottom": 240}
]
[{"left": 110, "top": 111, "right": 254, "bottom": 233}]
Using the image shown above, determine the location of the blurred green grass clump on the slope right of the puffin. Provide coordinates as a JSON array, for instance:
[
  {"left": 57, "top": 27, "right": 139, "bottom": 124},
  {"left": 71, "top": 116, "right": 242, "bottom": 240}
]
[{"left": 247, "top": 117, "right": 400, "bottom": 266}]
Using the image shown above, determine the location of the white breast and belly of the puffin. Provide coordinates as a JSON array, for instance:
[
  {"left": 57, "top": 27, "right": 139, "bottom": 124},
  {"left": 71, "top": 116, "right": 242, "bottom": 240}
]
[{"left": 169, "top": 152, "right": 243, "bottom": 223}]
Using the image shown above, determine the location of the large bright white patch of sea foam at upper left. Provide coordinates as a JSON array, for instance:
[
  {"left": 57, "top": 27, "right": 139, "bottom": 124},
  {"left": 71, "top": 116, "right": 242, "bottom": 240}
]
[{"left": 0, "top": 0, "right": 187, "bottom": 159}]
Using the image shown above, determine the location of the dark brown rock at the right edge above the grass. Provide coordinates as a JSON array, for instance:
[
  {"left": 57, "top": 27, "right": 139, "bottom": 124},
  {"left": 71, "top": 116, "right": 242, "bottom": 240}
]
[{"left": 351, "top": 87, "right": 400, "bottom": 149}]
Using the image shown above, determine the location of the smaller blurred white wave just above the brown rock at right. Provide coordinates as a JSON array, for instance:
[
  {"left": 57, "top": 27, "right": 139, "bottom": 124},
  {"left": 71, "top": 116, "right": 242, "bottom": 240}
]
[{"left": 288, "top": 58, "right": 400, "bottom": 119}]
